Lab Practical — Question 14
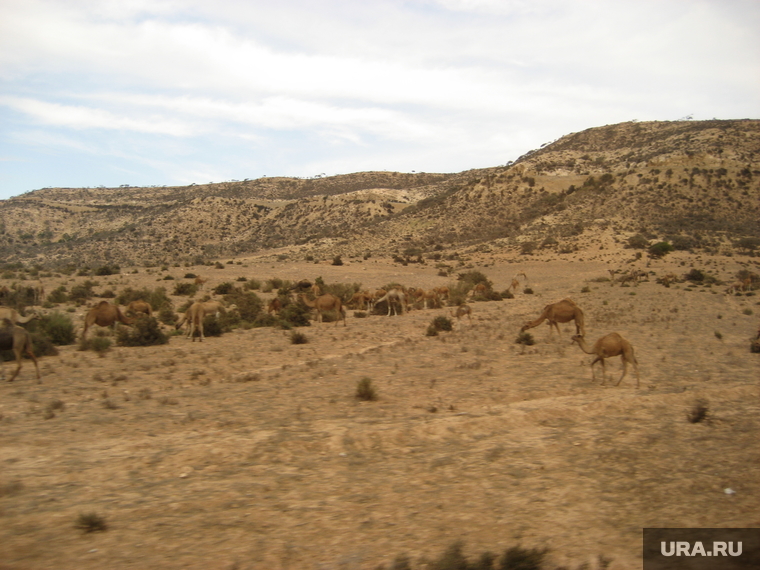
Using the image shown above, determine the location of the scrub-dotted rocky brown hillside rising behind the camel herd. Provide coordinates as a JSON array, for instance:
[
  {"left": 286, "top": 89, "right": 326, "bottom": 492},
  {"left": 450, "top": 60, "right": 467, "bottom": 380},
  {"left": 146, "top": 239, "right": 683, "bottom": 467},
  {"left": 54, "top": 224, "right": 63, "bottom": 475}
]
[{"left": 0, "top": 120, "right": 760, "bottom": 266}]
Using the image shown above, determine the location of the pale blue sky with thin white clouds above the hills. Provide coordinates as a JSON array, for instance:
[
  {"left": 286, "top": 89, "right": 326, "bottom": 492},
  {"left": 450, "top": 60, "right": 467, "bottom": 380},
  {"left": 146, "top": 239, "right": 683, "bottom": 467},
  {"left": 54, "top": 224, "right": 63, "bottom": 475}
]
[{"left": 0, "top": 0, "right": 760, "bottom": 199}]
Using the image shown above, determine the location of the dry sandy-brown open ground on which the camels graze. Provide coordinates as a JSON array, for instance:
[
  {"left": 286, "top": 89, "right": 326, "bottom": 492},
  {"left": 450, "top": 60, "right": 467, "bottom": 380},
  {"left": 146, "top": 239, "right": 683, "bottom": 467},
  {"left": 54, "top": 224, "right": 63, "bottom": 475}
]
[{"left": 0, "top": 253, "right": 760, "bottom": 570}]
